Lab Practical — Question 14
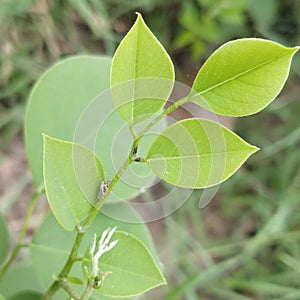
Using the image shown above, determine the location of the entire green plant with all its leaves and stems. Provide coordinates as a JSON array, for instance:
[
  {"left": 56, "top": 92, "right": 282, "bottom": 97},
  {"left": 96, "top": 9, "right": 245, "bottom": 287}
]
[{"left": 0, "top": 15, "right": 298, "bottom": 299}]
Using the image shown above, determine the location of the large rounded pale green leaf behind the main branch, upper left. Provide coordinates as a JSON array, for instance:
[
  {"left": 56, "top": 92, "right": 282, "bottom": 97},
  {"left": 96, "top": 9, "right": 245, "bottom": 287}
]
[{"left": 25, "top": 55, "right": 162, "bottom": 202}]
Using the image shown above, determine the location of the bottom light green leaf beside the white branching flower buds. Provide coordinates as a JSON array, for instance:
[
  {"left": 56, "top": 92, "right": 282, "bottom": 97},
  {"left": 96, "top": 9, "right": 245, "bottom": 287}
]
[{"left": 83, "top": 231, "right": 165, "bottom": 297}]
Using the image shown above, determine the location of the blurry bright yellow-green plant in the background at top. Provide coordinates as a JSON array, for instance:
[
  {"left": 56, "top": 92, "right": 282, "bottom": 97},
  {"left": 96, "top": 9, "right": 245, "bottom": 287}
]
[{"left": 173, "top": 0, "right": 249, "bottom": 61}]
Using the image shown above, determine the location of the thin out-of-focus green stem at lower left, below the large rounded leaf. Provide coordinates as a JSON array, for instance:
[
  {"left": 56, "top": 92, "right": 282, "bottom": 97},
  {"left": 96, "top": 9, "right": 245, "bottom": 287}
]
[{"left": 0, "top": 184, "right": 44, "bottom": 279}]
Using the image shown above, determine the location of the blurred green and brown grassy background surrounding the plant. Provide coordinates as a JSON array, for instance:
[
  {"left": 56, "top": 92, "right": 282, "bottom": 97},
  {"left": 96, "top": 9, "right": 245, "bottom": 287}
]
[{"left": 0, "top": 0, "right": 300, "bottom": 300}]
